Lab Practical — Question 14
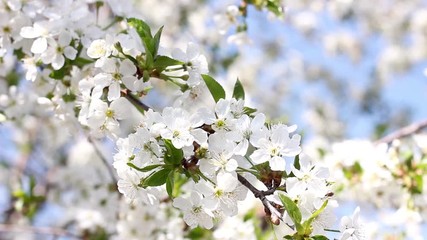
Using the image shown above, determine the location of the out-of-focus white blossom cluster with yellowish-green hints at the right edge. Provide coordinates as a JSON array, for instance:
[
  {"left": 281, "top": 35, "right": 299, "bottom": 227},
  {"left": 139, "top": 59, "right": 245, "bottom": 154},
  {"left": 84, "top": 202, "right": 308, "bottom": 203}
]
[{"left": 307, "top": 134, "right": 427, "bottom": 239}]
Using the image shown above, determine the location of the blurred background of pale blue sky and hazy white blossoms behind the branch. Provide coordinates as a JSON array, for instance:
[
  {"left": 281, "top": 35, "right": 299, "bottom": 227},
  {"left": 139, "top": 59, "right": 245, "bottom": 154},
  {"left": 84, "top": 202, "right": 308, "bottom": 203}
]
[{"left": 0, "top": 0, "right": 427, "bottom": 239}]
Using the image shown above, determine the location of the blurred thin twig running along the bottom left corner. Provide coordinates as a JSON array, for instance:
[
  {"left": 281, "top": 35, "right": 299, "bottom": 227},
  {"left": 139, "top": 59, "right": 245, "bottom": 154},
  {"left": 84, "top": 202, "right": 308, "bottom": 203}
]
[{"left": 0, "top": 224, "right": 80, "bottom": 239}]
